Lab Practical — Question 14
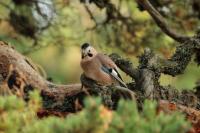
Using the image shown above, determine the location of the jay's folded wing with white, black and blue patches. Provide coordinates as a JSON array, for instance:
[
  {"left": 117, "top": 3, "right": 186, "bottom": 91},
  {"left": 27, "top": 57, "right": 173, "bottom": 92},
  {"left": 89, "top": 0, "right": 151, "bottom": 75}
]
[{"left": 97, "top": 54, "right": 127, "bottom": 88}]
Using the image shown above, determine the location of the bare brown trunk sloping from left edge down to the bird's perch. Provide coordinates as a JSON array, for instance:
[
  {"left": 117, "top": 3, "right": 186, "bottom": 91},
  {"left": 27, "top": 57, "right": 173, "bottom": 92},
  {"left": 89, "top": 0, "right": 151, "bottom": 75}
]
[{"left": 0, "top": 41, "right": 81, "bottom": 95}]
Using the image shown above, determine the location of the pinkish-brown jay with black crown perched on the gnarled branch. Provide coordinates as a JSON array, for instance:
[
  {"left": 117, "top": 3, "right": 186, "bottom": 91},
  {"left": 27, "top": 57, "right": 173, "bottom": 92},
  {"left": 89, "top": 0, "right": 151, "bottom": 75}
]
[{"left": 80, "top": 43, "right": 127, "bottom": 88}]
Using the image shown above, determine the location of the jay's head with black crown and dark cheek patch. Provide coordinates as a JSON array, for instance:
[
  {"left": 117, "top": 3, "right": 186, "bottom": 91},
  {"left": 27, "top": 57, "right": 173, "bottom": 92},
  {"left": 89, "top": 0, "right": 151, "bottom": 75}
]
[{"left": 81, "top": 43, "right": 97, "bottom": 59}]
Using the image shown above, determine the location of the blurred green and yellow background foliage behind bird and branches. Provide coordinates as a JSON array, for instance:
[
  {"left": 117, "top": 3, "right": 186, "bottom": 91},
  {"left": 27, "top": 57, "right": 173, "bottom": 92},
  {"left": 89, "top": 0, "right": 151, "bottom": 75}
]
[{"left": 0, "top": 0, "right": 200, "bottom": 89}]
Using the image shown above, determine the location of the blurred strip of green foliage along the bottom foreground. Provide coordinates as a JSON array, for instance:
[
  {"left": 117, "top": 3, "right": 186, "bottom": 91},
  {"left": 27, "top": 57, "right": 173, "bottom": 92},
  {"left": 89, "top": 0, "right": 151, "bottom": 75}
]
[{"left": 0, "top": 92, "right": 190, "bottom": 133}]
